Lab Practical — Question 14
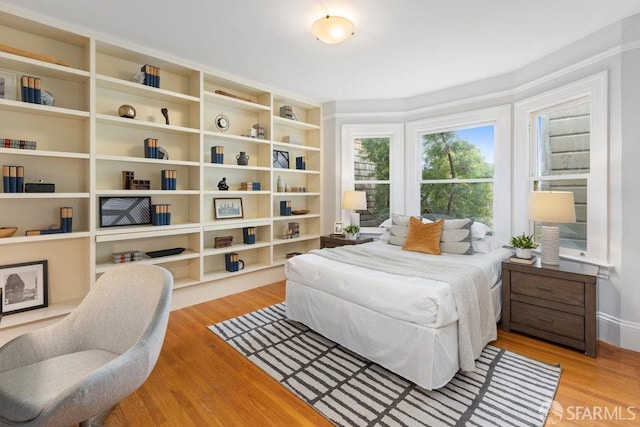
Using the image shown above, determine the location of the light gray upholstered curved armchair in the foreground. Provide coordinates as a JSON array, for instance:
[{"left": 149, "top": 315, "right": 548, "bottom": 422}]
[{"left": 0, "top": 264, "right": 173, "bottom": 426}]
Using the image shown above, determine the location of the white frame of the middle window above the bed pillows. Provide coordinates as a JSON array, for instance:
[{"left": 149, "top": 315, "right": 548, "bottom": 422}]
[{"left": 405, "top": 104, "right": 511, "bottom": 242}]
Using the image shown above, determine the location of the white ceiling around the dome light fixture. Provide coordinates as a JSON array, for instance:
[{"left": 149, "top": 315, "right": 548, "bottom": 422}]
[{"left": 0, "top": 0, "right": 640, "bottom": 102}]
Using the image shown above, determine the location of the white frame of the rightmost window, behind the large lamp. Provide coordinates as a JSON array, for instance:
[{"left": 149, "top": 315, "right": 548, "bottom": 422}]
[{"left": 513, "top": 71, "right": 609, "bottom": 265}]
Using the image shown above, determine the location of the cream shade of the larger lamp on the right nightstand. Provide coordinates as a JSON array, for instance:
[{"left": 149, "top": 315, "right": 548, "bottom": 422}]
[{"left": 529, "top": 191, "right": 576, "bottom": 224}]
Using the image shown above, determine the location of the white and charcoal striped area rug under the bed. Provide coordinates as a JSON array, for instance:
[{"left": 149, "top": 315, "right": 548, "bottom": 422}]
[{"left": 209, "top": 303, "right": 560, "bottom": 427}]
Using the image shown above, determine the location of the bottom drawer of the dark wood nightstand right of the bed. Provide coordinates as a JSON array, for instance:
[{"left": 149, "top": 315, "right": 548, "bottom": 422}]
[{"left": 511, "top": 301, "right": 584, "bottom": 341}]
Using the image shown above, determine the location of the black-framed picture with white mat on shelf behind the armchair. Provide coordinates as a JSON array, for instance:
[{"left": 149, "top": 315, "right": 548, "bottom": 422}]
[{"left": 0, "top": 260, "right": 49, "bottom": 315}]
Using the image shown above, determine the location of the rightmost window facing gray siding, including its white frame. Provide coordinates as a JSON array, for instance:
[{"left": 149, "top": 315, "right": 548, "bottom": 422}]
[{"left": 514, "top": 72, "right": 608, "bottom": 264}]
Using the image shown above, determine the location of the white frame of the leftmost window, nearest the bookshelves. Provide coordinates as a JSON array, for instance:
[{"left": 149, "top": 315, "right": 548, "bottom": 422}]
[{"left": 336, "top": 123, "right": 404, "bottom": 234}]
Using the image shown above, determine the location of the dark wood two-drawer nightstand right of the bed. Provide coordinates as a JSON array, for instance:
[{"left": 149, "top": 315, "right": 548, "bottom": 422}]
[{"left": 502, "top": 258, "right": 598, "bottom": 357}]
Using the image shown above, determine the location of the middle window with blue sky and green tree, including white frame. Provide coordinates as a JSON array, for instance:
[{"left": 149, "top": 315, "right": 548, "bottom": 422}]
[{"left": 406, "top": 106, "right": 511, "bottom": 241}]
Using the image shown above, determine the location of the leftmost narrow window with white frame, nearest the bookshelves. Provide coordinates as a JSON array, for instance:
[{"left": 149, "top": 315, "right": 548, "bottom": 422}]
[{"left": 337, "top": 124, "right": 403, "bottom": 232}]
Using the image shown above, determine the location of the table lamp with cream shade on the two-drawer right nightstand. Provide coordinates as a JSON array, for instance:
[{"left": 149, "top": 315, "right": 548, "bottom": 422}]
[{"left": 529, "top": 191, "right": 576, "bottom": 265}]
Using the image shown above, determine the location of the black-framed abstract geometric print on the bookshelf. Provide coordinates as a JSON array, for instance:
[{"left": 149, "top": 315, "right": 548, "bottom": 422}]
[{"left": 100, "top": 196, "right": 151, "bottom": 227}]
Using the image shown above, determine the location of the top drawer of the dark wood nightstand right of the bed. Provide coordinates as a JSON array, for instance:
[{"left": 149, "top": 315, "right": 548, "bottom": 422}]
[{"left": 511, "top": 271, "right": 584, "bottom": 307}]
